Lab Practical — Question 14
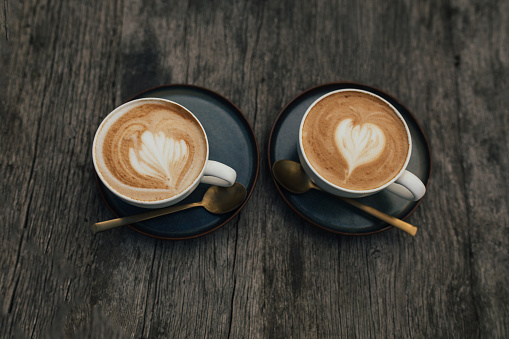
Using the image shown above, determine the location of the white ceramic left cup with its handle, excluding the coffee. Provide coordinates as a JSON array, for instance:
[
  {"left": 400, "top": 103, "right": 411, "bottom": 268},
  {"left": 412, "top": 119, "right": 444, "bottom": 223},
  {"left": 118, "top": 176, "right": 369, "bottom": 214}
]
[{"left": 92, "top": 98, "right": 237, "bottom": 208}]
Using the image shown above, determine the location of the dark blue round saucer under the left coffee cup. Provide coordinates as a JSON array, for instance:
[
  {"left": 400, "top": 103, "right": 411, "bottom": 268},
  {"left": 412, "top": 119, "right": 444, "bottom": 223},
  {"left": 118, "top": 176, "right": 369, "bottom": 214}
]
[{"left": 96, "top": 85, "right": 260, "bottom": 240}]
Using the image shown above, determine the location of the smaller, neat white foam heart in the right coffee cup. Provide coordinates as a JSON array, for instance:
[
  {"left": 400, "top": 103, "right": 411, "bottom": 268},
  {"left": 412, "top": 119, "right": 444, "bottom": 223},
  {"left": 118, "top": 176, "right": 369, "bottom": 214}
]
[{"left": 335, "top": 119, "right": 385, "bottom": 177}]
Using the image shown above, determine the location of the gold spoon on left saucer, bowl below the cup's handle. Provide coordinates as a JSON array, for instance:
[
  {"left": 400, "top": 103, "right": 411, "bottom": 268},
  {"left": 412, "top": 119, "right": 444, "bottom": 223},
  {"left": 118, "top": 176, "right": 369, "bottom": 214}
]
[{"left": 92, "top": 182, "right": 247, "bottom": 234}]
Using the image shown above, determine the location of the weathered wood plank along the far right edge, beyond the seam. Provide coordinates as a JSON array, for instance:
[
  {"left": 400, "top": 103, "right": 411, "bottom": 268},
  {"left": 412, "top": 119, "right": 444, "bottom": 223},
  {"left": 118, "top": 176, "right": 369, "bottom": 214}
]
[{"left": 453, "top": 1, "right": 509, "bottom": 338}]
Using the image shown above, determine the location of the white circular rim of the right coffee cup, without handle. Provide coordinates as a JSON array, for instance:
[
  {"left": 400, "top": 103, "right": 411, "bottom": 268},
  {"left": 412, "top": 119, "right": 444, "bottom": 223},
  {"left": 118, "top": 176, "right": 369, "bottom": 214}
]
[{"left": 299, "top": 88, "right": 412, "bottom": 195}]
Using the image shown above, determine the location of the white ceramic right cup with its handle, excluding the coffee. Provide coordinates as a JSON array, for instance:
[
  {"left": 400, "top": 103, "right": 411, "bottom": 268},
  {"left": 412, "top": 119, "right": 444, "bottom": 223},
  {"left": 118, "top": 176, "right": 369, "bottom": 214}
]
[{"left": 298, "top": 88, "right": 426, "bottom": 201}]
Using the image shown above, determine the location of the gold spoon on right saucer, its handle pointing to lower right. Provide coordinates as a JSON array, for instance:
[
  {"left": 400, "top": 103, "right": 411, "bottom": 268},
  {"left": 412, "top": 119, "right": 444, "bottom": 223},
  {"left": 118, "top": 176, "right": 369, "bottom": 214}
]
[{"left": 272, "top": 160, "right": 417, "bottom": 236}]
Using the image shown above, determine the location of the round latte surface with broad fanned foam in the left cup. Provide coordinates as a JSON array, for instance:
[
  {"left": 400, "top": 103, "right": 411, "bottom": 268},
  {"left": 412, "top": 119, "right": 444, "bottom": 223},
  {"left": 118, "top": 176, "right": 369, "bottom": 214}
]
[{"left": 94, "top": 101, "right": 207, "bottom": 201}]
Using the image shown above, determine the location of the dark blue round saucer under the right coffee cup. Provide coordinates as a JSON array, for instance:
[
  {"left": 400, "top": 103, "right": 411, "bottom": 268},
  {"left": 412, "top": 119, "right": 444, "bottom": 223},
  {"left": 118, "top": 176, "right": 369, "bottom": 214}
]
[{"left": 268, "top": 82, "right": 431, "bottom": 235}]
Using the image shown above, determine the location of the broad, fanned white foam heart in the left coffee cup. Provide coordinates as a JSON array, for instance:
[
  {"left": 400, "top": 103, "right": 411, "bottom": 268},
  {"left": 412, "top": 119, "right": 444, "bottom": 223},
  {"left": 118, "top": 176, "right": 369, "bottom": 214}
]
[{"left": 129, "top": 131, "right": 189, "bottom": 187}]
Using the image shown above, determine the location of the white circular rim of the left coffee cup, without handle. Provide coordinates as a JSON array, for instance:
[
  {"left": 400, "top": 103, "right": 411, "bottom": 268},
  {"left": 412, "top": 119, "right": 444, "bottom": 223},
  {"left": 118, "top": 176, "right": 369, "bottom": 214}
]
[{"left": 92, "top": 97, "right": 210, "bottom": 207}]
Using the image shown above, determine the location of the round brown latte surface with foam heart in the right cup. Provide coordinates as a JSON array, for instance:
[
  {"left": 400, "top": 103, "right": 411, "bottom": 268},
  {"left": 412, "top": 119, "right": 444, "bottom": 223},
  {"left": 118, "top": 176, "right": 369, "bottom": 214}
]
[{"left": 302, "top": 91, "right": 409, "bottom": 190}]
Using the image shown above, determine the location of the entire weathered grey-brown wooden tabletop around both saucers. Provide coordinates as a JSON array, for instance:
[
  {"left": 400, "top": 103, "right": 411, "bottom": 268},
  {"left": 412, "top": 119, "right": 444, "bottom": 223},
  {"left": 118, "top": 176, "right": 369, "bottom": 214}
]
[{"left": 0, "top": 0, "right": 509, "bottom": 338}]
